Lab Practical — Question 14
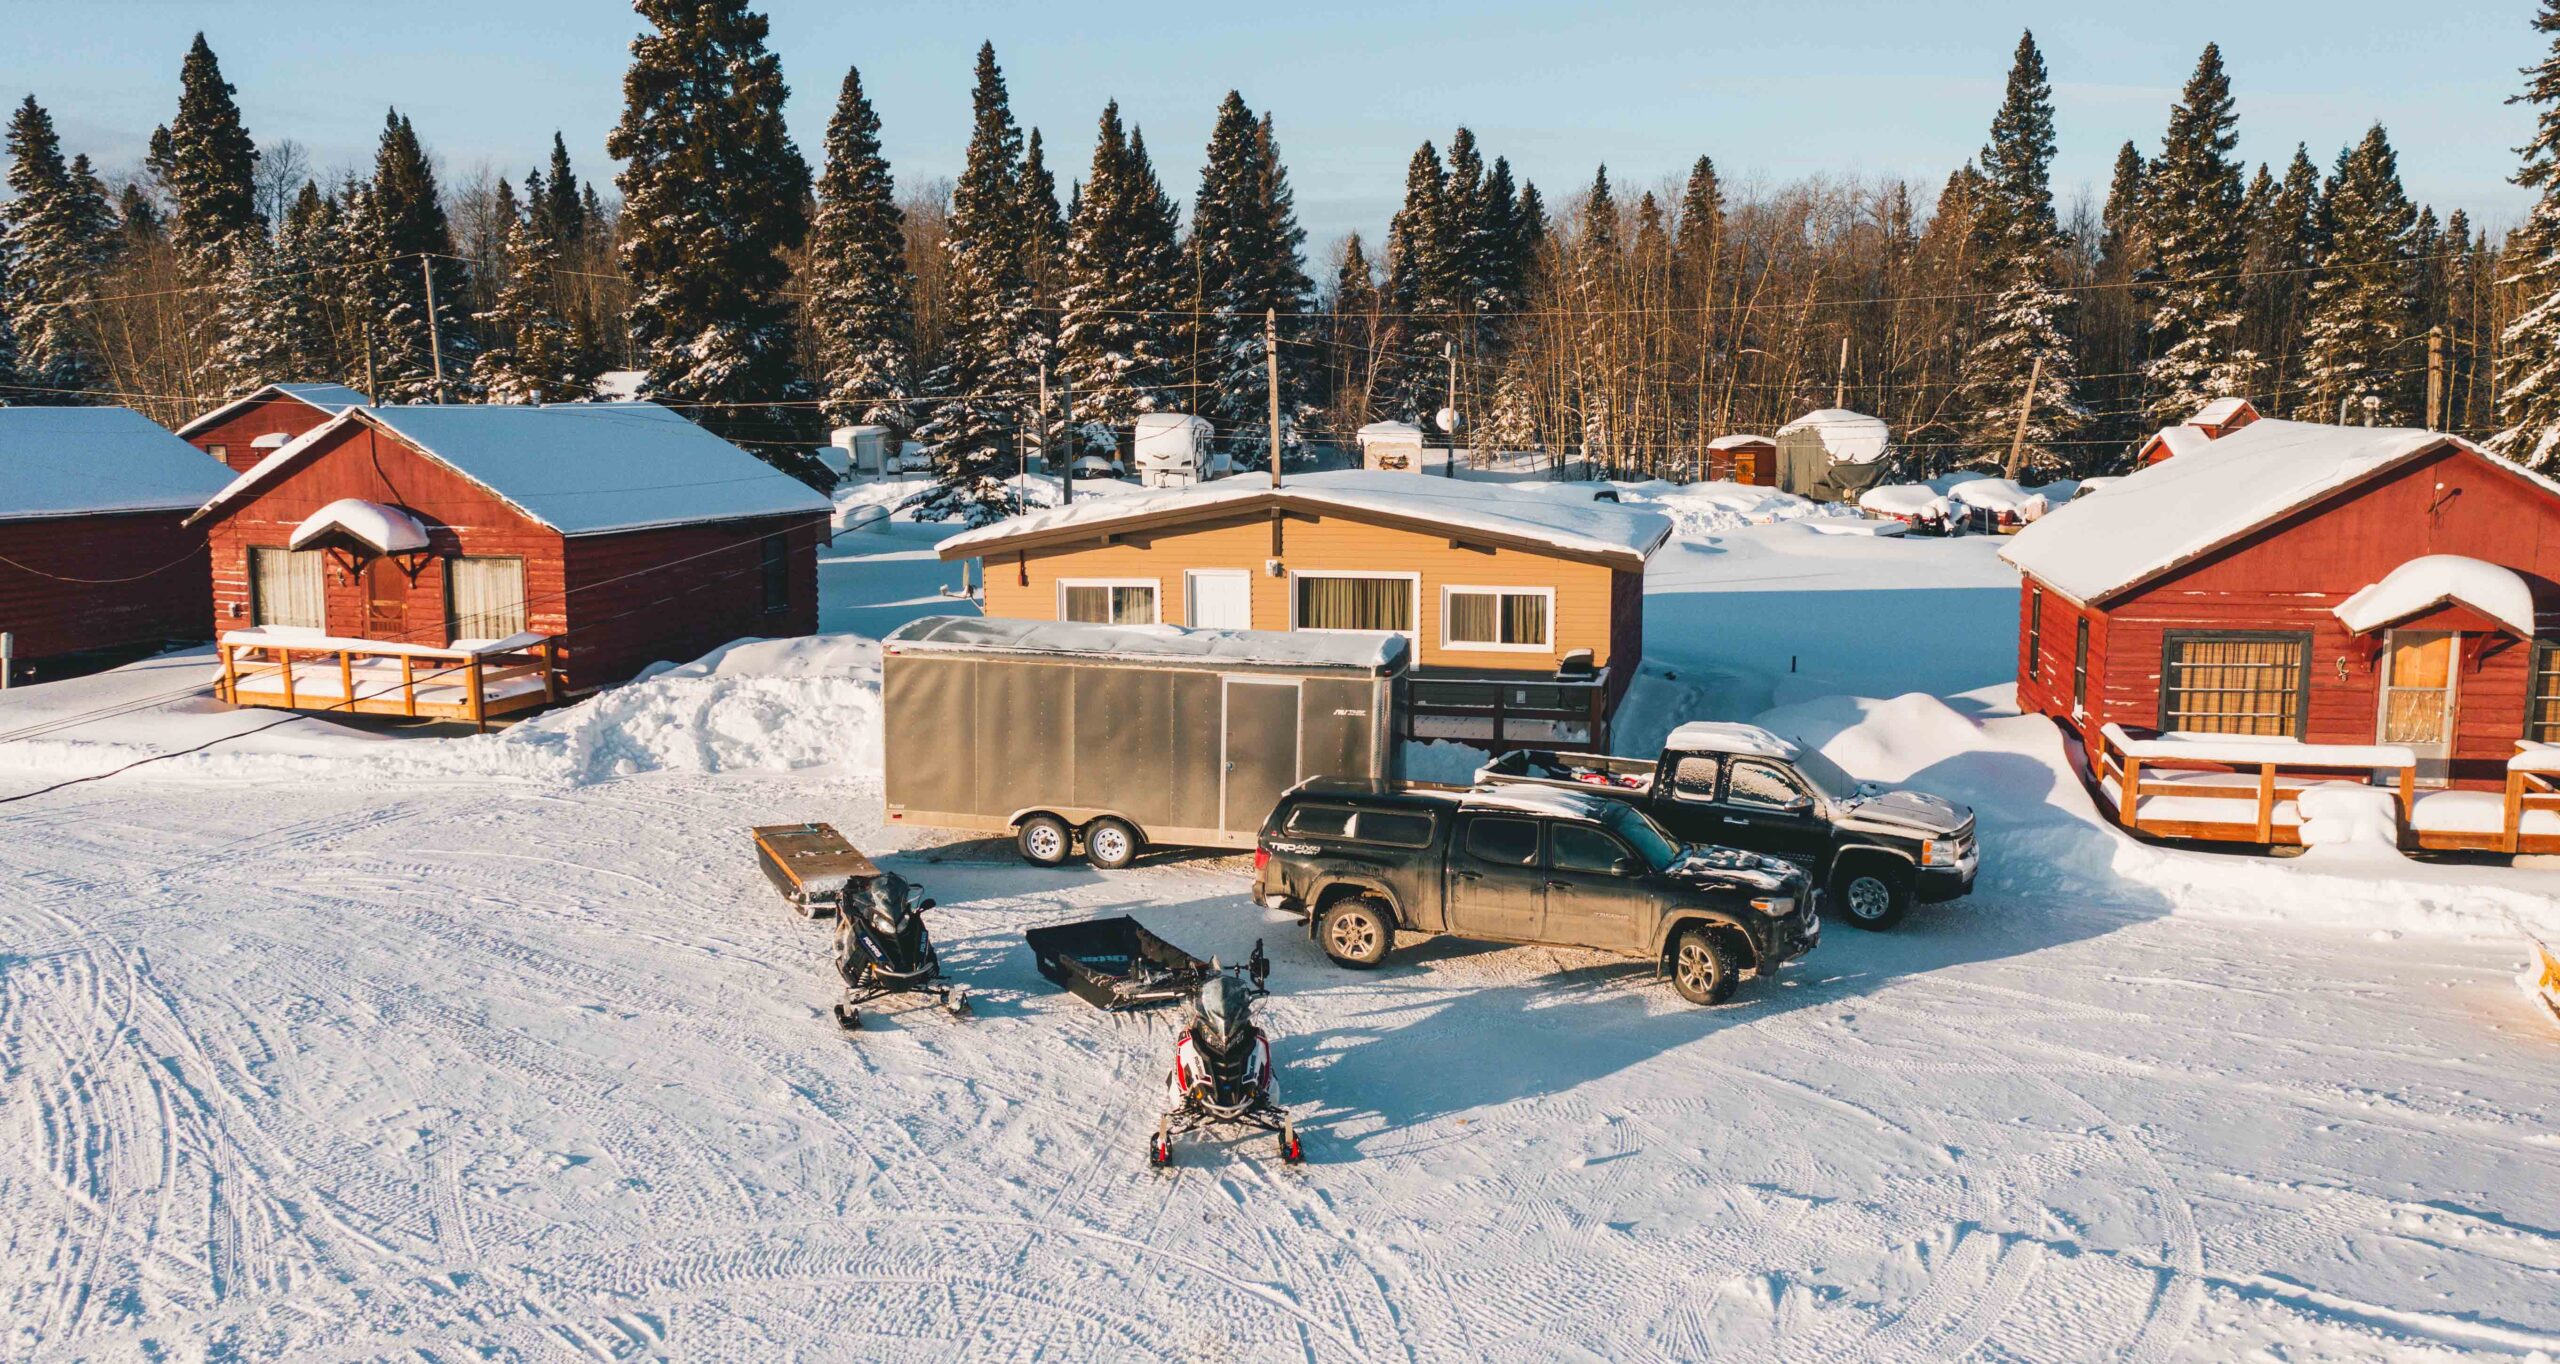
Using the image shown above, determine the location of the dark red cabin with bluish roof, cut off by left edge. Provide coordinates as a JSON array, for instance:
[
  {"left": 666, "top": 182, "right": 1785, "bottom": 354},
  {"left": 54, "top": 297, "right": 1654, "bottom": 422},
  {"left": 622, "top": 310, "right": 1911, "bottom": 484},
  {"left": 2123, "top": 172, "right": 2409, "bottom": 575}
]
[{"left": 0, "top": 407, "right": 228, "bottom": 673}]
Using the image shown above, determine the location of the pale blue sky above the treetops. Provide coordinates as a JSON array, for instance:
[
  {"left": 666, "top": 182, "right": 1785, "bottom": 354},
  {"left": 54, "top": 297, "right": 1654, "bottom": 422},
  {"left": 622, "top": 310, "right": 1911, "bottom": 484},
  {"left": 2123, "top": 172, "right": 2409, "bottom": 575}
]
[{"left": 0, "top": 0, "right": 2540, "bottom": 253}]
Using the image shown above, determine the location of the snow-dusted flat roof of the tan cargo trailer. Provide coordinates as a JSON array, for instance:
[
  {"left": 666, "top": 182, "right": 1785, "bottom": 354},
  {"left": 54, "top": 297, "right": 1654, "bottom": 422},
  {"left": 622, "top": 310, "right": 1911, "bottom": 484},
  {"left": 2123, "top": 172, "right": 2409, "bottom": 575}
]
[{"left": 881, "top": 617, "right": 1411, "bottom": 673}]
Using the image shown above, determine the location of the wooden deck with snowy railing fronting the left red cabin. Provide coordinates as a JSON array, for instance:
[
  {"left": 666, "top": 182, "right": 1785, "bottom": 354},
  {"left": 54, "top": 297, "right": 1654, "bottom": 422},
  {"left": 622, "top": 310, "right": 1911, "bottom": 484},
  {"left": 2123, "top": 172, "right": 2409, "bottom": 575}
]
[{"left": 212, "top": 630, "right": 561, "bottom": 729}]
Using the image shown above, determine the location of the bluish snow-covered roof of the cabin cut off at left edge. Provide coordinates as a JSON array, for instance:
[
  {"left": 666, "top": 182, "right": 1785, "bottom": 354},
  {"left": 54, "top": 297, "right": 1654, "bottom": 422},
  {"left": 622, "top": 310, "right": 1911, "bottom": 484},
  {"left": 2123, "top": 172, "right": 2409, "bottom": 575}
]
[{"left": 0, "top": 407, "right": 230, "bottom": 519}]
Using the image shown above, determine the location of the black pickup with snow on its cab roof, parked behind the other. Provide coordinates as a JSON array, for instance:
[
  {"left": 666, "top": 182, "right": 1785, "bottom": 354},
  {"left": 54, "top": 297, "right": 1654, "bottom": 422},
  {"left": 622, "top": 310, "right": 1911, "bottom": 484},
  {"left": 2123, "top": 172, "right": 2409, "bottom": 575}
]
[{"left": 1475, "top": 722, "right": 1981, "bottom": 929}]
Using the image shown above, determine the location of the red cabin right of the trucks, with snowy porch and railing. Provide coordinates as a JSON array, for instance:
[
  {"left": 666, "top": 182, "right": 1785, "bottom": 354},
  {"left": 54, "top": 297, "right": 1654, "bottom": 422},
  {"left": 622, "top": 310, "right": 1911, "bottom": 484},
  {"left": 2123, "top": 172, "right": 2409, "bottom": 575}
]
[{"left": 2002, "top": 420, "right": 2560, "bottom": 852}]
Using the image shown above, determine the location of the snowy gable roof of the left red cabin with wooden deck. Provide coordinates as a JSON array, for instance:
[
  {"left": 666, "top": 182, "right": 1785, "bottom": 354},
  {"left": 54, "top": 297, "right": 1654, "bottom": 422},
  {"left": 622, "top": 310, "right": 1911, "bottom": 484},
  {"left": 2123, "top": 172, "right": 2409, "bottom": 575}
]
[{"left": 197, "top": 402, "right": 835, "bottom": 535}]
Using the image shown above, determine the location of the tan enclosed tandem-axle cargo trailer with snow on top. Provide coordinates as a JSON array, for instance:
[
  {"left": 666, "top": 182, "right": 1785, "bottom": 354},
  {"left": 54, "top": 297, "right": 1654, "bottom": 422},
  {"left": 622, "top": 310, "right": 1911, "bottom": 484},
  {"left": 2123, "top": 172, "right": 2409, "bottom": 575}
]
[{"left": 881, "top": 617, "right": 1411, "bottom": 868}]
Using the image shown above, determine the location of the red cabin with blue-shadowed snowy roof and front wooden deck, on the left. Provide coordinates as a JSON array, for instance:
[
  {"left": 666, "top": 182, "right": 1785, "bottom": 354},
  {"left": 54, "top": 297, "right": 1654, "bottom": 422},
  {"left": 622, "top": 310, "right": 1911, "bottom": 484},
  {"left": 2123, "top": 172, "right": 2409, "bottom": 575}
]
[{"left": 195, "top": 402, "right": 832, "bottom": 724}]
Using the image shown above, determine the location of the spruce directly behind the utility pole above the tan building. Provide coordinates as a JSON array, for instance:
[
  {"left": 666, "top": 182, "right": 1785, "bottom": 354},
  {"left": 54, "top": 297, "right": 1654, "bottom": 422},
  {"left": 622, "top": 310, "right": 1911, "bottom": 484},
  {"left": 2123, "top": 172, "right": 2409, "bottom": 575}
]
[{"left": 1190, "top": 90, "right": 1313, "bottom": 463}]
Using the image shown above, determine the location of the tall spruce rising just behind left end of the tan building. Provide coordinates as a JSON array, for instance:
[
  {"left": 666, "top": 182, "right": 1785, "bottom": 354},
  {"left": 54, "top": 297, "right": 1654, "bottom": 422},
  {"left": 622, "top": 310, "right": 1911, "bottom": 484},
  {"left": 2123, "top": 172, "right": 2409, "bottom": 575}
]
[{"left": 914, "top": 44, "right": 1042, "bottom": 525}]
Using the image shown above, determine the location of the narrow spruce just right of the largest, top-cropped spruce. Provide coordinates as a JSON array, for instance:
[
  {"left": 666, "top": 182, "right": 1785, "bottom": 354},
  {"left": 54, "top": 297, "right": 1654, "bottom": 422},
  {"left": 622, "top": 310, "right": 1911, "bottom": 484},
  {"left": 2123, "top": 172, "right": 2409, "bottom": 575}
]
[{"left": 809, "top": 69, "right": 916, "bottom": 440}]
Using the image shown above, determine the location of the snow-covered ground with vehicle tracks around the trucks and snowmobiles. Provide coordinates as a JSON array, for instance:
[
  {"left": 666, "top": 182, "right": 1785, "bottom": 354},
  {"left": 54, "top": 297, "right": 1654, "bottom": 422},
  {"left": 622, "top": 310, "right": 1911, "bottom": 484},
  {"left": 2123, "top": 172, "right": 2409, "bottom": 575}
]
[{"left": 0, "top": 489, "right": 2560, "bottom": 1361}]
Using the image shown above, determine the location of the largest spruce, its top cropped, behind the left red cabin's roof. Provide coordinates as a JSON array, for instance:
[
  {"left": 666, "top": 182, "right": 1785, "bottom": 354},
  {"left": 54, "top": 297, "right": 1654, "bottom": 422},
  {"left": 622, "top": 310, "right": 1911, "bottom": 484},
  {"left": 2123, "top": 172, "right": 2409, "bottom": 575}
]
[{"left": 604, "top": 0, "right": 829, "bottom": 473}]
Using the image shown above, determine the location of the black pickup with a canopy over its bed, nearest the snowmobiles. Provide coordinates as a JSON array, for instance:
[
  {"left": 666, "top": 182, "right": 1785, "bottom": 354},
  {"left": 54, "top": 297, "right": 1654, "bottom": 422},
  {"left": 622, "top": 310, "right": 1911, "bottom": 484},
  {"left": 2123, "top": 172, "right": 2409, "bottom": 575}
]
[{"left": 1254, "top": 778, "right": 1823, "bottom": 1003}]
